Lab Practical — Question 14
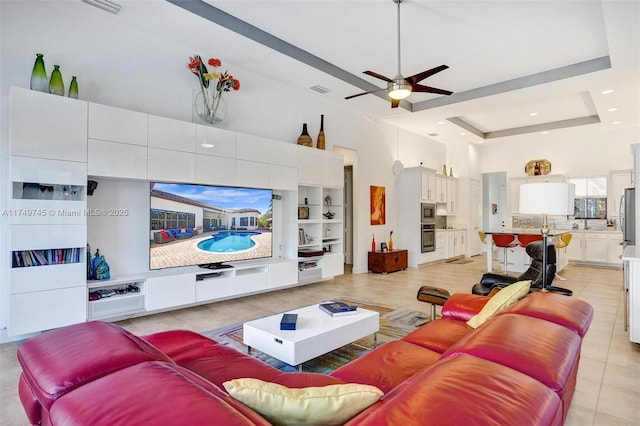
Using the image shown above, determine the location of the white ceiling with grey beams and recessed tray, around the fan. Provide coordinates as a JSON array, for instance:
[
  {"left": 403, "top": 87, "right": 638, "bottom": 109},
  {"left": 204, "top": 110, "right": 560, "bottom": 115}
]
[{"left": 109, "top": 0, "right": 640, "bottom": 143}]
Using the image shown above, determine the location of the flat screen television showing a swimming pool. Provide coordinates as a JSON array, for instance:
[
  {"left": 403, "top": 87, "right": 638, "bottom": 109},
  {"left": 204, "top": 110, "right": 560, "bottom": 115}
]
[{"left": 149, "top": 182, "right": 273, "bottom": 270}]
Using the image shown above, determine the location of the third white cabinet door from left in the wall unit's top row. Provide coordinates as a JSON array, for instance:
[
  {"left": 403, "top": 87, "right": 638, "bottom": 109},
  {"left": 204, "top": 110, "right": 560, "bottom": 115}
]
[{"left": 148, "top": 115, "right": 197, "bottom": 153}]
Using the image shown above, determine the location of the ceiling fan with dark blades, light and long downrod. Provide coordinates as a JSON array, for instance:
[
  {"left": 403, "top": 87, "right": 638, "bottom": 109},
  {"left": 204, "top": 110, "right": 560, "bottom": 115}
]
[{"left": 345, "top": 0, "right": 453, "bottom": 108}]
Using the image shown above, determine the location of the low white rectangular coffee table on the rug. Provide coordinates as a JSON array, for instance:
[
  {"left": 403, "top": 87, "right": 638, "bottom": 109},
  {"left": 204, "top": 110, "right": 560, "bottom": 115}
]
[{"left": 242, "top": 302, "right": 380, "bottom": 370}]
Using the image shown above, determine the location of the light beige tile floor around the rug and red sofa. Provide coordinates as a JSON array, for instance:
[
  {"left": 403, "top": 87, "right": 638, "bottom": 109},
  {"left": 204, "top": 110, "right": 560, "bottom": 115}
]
[{"left": 0, "top": 256, "right": 640, "bottom": 426}]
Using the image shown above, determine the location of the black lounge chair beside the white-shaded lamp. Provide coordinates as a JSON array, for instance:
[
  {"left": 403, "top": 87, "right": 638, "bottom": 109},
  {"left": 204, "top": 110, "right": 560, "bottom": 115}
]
[{"left": 471, "top": 241, "right": 573, "bottom": 296}]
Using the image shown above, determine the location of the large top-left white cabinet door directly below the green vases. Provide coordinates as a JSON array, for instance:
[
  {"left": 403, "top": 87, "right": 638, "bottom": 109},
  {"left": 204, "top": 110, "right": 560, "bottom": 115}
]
[{"left": 9, "top": 87, "right": 87, "bottom": 163}]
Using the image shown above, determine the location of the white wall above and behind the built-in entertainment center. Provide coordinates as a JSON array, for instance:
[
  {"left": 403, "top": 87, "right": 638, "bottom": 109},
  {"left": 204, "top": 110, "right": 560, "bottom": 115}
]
[{"left": 0, "top": 0, "right": 446, "bottom": 329}]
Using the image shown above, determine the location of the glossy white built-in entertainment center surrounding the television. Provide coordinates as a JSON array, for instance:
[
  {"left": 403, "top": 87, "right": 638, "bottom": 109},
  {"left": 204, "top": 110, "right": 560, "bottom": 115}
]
[{"left": 7, "top": 87, "right": 344, "bottom": 336}]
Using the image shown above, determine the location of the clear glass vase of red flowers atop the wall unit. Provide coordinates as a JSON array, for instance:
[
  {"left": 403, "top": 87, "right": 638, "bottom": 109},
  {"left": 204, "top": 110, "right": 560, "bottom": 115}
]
[{"left": 187, "top": 55, "right": 240, "bottom": 124}]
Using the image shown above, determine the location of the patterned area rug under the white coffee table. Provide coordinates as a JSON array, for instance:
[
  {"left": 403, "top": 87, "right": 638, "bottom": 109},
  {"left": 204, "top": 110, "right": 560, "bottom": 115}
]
[{"left": 202, "top": 297, "right": 428, "bottom": 374}]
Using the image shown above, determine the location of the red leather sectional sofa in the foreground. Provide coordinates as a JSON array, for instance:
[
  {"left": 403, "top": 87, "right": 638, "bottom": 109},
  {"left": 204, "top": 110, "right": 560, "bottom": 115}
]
[{"left": 18, "top": 293, "right": 593, "bottom": 426}]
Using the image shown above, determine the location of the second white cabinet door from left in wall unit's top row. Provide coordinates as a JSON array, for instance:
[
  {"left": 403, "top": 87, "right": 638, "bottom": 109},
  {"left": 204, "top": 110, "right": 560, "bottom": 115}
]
[{"left": 88, "top": 102, "right": 149, "bottom": 146}]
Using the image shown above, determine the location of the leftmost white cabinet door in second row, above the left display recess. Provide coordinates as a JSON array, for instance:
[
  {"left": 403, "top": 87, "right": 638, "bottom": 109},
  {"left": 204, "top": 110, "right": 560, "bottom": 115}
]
[{"left": 87, "top": 139, "right": 147, "bottom": 179}]
